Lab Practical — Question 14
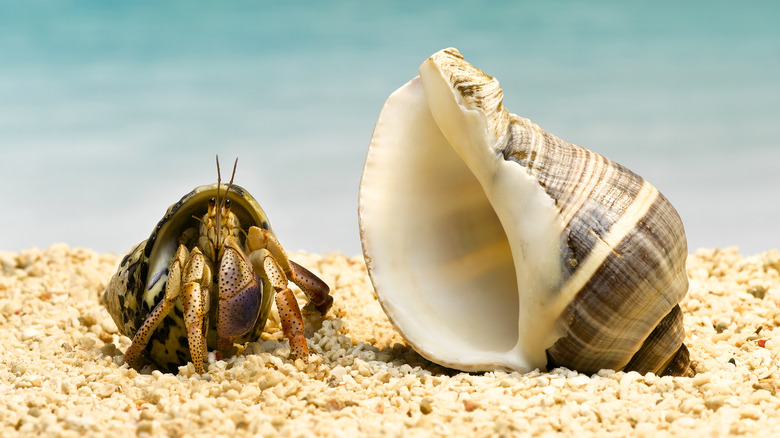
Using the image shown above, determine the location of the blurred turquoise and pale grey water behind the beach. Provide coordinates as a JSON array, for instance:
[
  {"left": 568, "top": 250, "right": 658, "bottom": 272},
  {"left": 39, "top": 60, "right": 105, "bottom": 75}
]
[{"left": 0, "top": 0, "right": 780, "bottom": 255}]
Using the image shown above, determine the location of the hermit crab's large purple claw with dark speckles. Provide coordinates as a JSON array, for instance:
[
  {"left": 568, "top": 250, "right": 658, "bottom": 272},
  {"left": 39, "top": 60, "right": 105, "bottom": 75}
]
[{"left": 217, "top": 237, "right": 262, "bottom": 353}]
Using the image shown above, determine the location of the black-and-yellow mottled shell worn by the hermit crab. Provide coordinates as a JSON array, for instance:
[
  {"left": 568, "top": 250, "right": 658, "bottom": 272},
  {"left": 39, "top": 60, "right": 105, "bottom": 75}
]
[{"left": 103, "top": 184, "right": 273, "bottom": 371}]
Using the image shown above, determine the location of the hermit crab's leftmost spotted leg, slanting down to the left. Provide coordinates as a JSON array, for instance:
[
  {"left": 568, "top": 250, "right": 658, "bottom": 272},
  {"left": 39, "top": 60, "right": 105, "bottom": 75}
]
[{"left": 124, "top": 246, "right": 189, "bottom": 367}]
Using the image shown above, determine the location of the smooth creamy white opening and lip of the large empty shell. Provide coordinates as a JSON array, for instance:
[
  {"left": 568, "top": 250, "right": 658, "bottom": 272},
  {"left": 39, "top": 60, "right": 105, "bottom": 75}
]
[{"left": 359, "top": 65, "right": 563, "bottom": 371}]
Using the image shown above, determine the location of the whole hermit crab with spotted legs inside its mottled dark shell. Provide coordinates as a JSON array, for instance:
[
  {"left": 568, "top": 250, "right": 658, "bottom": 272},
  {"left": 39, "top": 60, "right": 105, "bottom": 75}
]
[{"left": 102, "top": 159, "right": 333, "bottom": 374}]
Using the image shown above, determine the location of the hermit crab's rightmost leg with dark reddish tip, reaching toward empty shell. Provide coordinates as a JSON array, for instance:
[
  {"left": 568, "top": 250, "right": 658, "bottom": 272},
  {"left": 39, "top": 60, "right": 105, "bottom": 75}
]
[{"left": 247, "top": 227, "right": 333, "bottom": 315}]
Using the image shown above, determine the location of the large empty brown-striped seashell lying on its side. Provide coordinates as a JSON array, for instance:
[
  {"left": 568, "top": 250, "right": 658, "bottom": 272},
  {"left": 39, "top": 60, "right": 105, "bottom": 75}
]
[{"left": 359, "top": 48, "right": 690, "bottom": 375}]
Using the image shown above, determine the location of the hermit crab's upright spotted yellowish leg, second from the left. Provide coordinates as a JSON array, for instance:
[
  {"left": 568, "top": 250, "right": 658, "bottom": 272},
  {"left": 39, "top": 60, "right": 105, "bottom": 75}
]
[{"left": 182, "top": 247, "right": 211, "bottom": 374}]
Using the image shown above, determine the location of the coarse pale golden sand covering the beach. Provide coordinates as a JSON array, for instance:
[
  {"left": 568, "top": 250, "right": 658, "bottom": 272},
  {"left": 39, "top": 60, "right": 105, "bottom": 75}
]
[{"left": 0, "top": 245, "right": 780, "bottom": 437}]
